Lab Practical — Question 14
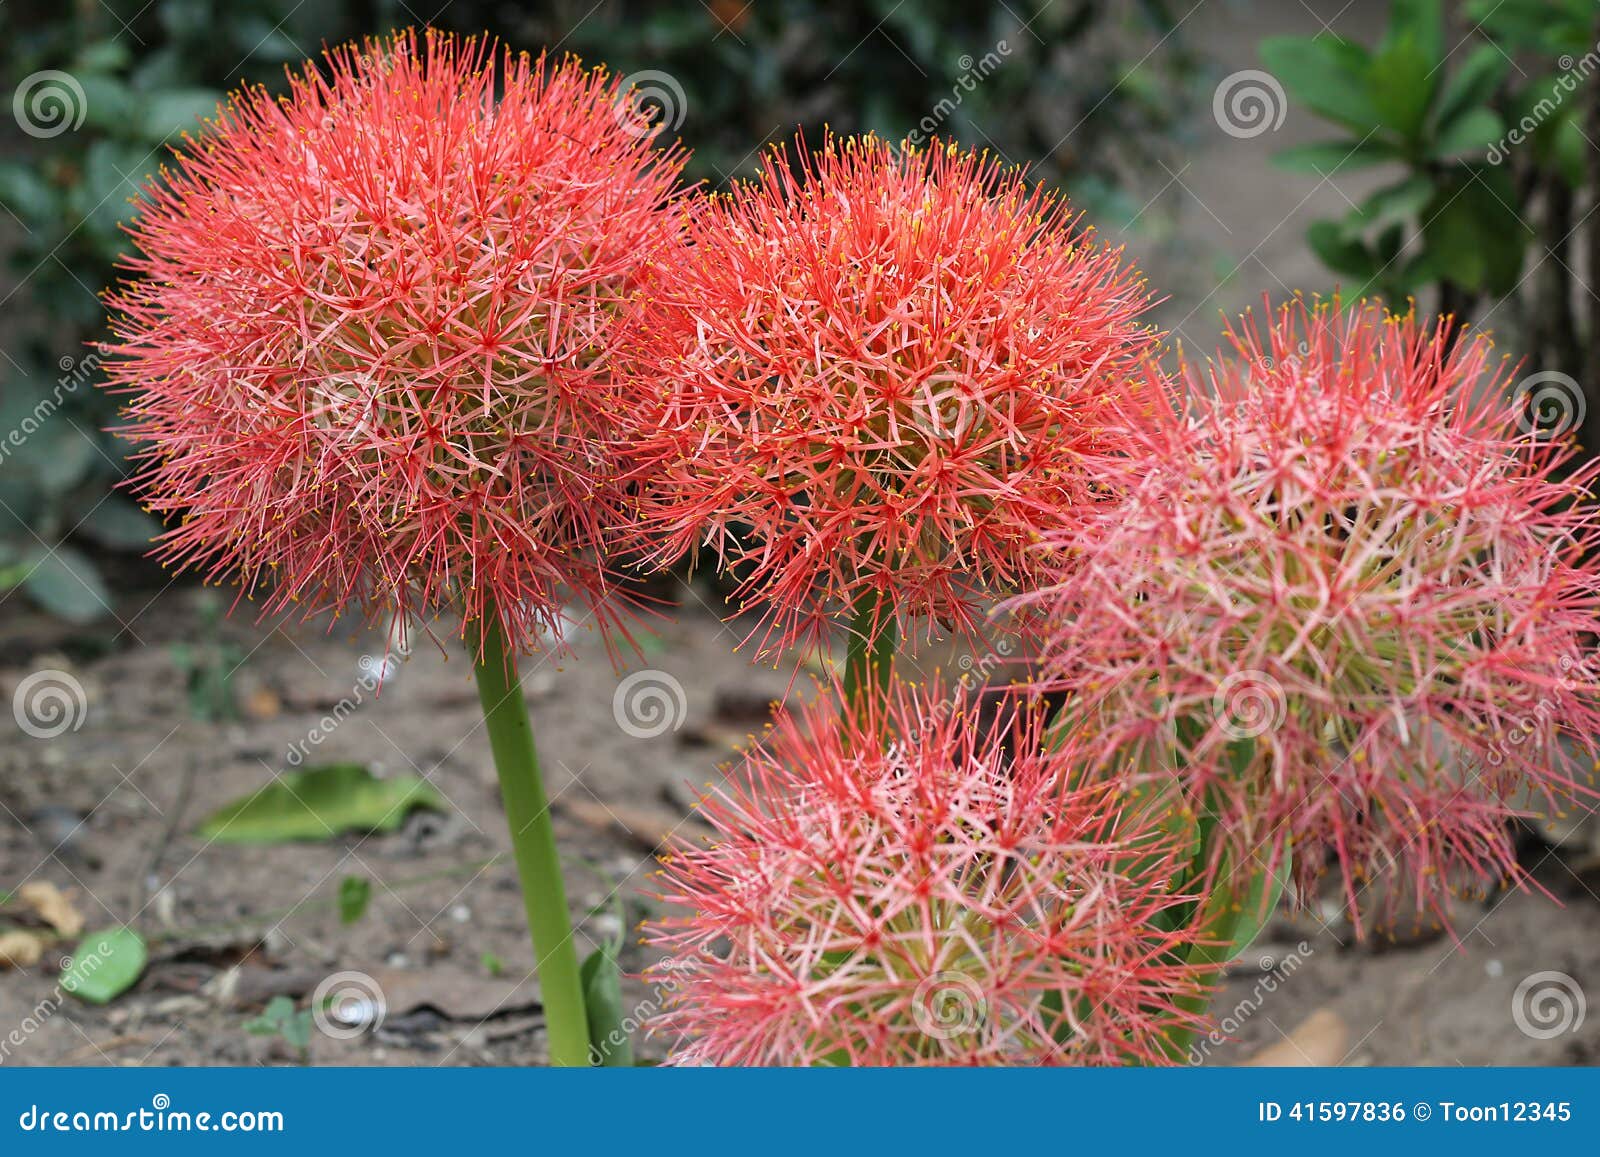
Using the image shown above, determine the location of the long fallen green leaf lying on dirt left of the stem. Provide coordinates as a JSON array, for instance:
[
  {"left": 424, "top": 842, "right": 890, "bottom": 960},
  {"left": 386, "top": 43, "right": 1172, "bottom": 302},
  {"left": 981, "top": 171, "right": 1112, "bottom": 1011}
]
[{"left": 197, "top": 763, "right": 445, "bottom": 843}]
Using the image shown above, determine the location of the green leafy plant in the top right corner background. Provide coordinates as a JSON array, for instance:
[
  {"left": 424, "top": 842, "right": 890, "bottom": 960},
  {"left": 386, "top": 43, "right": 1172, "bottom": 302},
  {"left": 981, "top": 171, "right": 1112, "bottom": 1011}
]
[{"left": 1261, "top": 0, "right": 1600, "bottom": 451}]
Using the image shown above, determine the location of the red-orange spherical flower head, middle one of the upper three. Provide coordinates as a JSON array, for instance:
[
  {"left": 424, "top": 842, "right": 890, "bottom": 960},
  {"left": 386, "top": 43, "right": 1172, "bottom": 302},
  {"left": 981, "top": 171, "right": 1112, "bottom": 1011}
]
[{"left": 626, "top": 138, "right": 1155, "bottom": 651}]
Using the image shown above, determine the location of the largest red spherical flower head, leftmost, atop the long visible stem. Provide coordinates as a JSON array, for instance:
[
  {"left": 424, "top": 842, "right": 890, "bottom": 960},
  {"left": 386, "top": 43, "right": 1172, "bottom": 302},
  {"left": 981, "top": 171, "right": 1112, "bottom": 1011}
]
[{"left": 104, "top": 32, "right": 682, "bottom": 643}]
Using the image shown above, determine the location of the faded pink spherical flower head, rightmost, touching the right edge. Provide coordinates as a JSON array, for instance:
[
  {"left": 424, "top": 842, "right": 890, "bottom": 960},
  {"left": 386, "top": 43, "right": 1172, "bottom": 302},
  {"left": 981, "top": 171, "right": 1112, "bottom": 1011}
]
[{"left": 1032, "top": 304, "right": 1600, "bottom": 919}]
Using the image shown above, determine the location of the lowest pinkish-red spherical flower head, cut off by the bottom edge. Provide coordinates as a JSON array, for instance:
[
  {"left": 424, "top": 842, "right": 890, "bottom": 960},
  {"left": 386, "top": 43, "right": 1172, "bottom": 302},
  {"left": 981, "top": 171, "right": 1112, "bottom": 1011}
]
[{"left": 646, "top": 690, "right": 1203, "bottom": 1066}]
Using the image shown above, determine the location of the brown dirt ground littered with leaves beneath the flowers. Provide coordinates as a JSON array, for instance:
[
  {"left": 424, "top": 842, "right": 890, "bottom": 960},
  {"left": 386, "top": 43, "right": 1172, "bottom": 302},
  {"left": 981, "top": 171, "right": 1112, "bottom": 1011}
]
[{"left": 0, "top": 586, "right": 1600, "bottom": 1066}]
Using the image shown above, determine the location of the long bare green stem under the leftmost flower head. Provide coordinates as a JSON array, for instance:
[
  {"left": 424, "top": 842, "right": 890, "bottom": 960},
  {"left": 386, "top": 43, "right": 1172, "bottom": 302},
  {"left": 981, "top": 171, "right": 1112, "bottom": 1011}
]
[{"left": 472, "top": 605, "right": 589, "bottom": 1066}]
